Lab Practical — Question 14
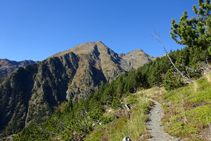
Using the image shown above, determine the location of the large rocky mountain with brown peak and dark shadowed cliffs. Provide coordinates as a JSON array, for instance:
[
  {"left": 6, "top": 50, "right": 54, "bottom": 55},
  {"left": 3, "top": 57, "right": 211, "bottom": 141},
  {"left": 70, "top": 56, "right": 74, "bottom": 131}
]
[{"left": 0, "top": 41, "right": 152, "bottom": 136}]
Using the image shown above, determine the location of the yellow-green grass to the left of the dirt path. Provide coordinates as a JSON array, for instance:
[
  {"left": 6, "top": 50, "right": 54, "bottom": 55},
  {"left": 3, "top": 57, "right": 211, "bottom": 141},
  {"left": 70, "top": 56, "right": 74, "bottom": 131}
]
[{"left": 85, "top": 93, "right": 153, "bottom": 141}]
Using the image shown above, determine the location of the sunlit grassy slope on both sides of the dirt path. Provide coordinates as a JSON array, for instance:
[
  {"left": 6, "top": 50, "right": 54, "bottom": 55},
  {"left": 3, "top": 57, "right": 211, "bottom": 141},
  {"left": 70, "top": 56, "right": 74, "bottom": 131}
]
[{"left": 85, "top": 76, "right": 211, "bottom": 141}]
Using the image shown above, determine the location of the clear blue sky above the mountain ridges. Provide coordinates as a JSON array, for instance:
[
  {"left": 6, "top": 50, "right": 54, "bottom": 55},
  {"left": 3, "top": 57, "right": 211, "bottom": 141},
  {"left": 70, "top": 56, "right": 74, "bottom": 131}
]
[{"left": 0, "top": 0, "right": 198, "bottom": 61}]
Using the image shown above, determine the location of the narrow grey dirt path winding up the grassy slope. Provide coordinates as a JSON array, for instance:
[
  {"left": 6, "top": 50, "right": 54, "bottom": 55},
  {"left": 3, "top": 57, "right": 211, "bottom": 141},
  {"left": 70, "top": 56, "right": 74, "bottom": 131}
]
[{"left": 147, "top": 99, "right": 180, "bottom": 141}]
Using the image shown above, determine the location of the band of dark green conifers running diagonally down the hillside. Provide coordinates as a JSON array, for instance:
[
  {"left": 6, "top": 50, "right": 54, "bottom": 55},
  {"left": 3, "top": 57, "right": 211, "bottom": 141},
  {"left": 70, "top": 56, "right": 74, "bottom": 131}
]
[{"left": 12, "top": 47, "right": 206, "bottom": 140}]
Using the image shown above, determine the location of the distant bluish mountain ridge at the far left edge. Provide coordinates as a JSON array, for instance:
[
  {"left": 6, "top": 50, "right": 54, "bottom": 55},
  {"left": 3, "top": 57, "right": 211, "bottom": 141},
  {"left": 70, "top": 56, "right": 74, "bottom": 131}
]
[{"left": 0, "top": 59, "right": 36, "bottom": 79}]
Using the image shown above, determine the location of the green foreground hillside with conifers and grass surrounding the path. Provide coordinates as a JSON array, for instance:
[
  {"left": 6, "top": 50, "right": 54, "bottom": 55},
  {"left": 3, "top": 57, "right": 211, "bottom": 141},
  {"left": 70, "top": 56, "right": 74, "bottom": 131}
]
[{"left": 5, "top": 43, "right": 208, "bottom": 141}]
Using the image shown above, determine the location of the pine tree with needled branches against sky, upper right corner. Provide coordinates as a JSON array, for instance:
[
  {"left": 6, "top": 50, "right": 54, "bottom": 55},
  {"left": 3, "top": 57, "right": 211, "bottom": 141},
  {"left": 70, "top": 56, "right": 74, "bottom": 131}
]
[{"left": 170, "top": 0, "right": 211, "bottom": 57}]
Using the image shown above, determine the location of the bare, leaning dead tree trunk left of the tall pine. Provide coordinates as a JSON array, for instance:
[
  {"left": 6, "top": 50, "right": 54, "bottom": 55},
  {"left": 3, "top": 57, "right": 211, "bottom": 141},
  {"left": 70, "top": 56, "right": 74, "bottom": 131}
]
[{"left": 152, "top": 31, "right": 192, "bottom": 83}]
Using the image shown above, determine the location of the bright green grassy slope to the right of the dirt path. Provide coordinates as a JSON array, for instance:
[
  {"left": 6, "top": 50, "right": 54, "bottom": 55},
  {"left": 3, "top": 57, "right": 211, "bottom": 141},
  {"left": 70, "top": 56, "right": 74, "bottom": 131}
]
[{"left": 146, "top": 75, "right": 211, "bottom": 140}]
